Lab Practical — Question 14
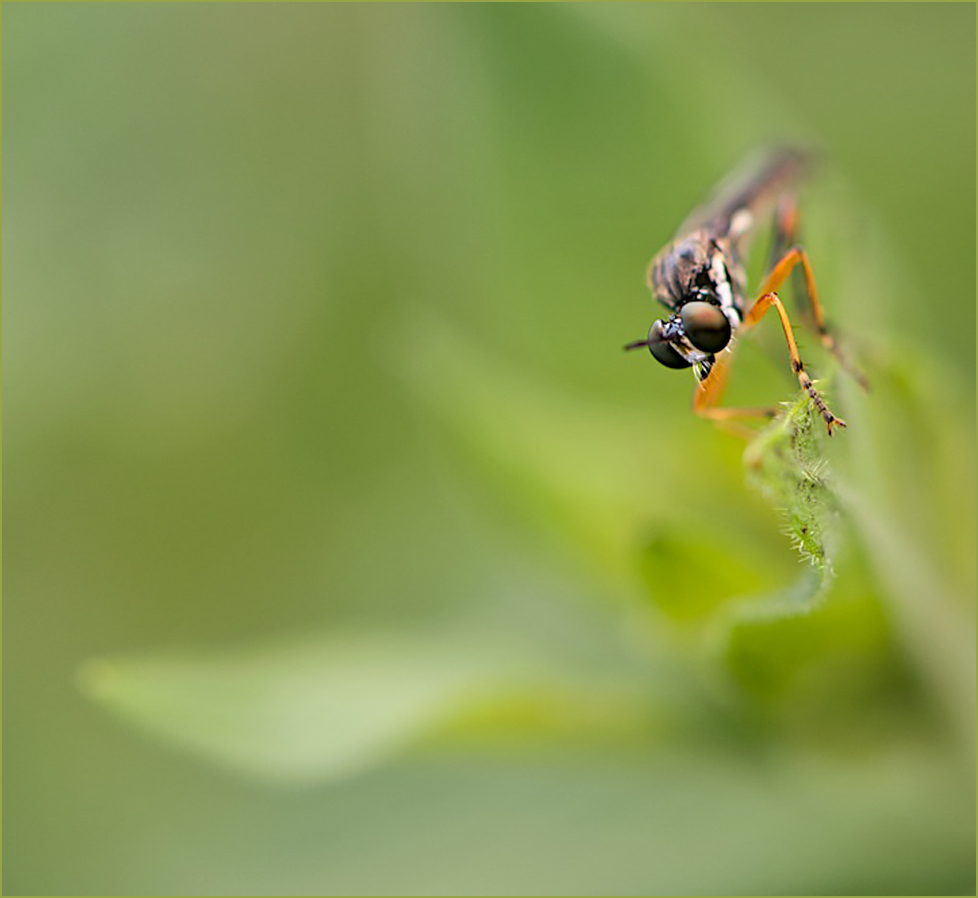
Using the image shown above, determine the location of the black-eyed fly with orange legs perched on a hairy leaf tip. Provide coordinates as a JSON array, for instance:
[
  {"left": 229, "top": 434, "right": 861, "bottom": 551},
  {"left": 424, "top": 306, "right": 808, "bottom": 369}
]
[{"left": 625, "top": 148, "right": 866, "bottom": 436}]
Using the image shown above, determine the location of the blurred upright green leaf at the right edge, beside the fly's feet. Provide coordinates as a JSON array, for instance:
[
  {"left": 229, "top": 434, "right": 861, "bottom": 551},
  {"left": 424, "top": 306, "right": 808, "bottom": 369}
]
[{"left": 837, "top": 349, "right": 975, "bottom": 753}]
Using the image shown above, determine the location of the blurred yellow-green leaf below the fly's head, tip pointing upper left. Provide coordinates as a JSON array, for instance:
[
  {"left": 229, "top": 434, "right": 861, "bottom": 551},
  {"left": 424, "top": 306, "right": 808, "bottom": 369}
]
[{"left": 392, "top": 316, "right": 669, "bottom": 566}]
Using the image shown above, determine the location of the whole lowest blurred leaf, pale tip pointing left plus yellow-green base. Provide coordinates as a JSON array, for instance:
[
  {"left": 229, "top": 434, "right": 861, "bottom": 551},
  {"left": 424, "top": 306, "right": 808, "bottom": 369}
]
[{"left": 79, "top": 631, "right": 660, "bottom": 782}]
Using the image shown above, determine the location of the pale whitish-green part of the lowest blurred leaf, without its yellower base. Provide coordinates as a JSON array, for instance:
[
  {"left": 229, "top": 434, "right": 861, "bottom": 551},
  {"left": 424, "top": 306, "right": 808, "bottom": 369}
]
[{"left": 80, "top": 634, "right": 519, "bottom": 780}]
